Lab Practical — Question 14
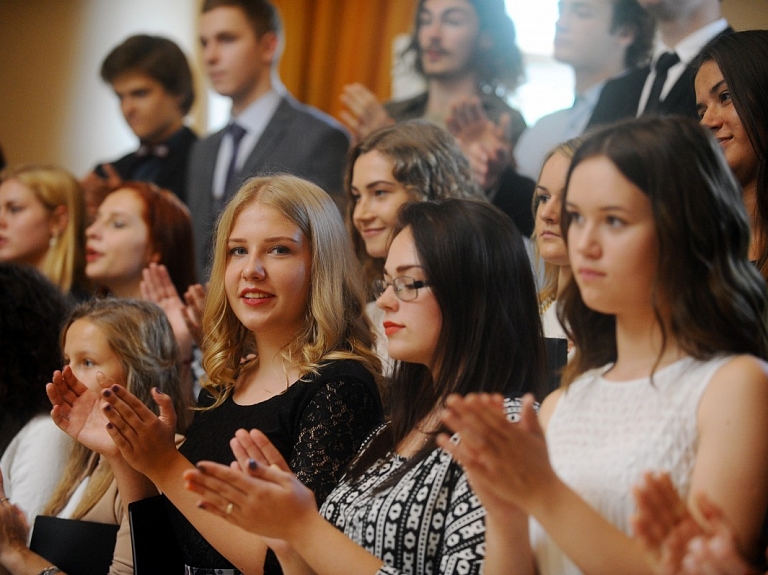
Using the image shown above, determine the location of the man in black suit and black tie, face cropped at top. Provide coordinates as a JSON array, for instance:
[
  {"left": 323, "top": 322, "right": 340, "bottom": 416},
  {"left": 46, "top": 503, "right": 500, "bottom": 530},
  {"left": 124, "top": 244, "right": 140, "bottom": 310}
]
[{"left": 587, "top": 0, "right": 733, "bottom": 128}]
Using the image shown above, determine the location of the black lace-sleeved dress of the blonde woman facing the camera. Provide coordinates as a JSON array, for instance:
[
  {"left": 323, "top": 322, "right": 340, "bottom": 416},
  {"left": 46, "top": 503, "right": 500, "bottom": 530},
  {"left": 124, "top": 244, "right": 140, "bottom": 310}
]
[{"left": 168, "top": 360, "right": 383, "bottom": 575}]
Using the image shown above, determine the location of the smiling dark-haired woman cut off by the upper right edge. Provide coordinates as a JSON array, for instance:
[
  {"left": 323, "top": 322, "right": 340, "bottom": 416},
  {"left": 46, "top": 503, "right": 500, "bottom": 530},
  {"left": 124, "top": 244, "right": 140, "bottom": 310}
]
[{"left": 695, "top": 30, "right": 768, "bottom": 279}]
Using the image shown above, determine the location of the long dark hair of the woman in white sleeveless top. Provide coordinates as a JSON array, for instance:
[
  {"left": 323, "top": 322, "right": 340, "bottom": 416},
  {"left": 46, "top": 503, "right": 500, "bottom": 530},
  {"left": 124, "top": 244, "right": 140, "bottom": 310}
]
[{"left": 558, "top": 117, "right": 768, "bottom": 384}]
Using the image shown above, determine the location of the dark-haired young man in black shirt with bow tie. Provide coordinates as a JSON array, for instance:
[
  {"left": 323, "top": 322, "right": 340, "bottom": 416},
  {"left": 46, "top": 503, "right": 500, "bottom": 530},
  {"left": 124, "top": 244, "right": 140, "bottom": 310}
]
[{"left": 82, "top": 34, "right": 197, "bottom": 218}]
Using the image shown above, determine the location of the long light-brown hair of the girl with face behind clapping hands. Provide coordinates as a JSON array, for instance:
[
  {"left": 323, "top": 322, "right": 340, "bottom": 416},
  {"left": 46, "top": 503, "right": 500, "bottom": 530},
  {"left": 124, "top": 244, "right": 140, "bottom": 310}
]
[{"left": 43, "top": 297, "right": 193, "bottom": 519}]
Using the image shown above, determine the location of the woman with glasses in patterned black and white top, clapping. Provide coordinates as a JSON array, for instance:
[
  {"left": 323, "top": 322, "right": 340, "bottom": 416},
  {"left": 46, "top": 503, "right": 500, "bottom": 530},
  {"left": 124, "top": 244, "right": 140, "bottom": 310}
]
[{"left": 185, "top": 199, "right": 544, "bottom": 575}]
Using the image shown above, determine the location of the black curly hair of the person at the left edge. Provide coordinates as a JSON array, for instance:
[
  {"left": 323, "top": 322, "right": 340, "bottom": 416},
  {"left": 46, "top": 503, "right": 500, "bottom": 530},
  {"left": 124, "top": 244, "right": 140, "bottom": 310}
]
[{"left": 0, "top": 263, "right": 67, "bottom": 455}]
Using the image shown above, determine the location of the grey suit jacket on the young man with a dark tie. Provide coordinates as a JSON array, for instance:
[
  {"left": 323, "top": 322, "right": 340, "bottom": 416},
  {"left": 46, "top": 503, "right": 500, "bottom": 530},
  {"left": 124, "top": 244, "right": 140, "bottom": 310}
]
[{"left": 187, "top": 95, "right": 349, "bottom": 281}]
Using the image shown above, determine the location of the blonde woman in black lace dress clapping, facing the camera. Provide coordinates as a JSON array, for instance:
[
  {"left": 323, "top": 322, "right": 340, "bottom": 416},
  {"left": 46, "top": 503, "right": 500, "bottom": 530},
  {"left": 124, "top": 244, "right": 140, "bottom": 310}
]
[{"left": 58, "top": 176, "right": 382, "bottom": 574}]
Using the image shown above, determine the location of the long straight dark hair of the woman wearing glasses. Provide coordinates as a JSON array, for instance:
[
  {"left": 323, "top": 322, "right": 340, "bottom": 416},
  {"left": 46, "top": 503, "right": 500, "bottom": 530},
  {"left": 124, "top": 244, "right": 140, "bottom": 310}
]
[{"left": 350, "top": 199, "right": 545, "bottom": 483}]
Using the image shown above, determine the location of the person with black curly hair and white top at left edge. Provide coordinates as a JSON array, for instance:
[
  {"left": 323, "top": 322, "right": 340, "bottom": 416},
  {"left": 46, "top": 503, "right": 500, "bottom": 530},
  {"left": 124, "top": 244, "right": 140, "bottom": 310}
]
[{"left": 0, "top": 263, "right": 72, "bottom": 520}]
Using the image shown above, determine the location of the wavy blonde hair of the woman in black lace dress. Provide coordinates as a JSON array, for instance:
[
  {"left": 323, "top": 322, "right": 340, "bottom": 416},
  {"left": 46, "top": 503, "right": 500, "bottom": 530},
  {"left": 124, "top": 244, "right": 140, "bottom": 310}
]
[{"left": 203, "top": 175, "right": 381, "bottom": 407}]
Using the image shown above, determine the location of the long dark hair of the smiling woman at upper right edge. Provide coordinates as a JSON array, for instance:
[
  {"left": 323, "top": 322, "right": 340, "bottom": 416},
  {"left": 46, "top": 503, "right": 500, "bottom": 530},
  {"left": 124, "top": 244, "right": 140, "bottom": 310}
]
[{"left": 694, "top": 30, "right": 768, "bottom": 280}]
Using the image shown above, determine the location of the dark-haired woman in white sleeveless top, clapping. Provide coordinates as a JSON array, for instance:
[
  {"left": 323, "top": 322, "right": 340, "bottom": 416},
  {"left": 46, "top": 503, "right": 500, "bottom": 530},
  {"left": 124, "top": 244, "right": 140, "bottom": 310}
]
[{"left": 440, "top": 118, "right": 768, "bottom": 575}]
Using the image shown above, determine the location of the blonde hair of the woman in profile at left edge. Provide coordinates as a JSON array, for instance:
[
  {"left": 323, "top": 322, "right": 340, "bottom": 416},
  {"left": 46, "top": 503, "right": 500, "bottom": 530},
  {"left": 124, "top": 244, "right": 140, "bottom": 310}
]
[{"left": 0, "top": 164, "right": 88, "bottom": 293}]
